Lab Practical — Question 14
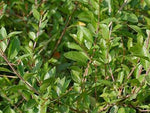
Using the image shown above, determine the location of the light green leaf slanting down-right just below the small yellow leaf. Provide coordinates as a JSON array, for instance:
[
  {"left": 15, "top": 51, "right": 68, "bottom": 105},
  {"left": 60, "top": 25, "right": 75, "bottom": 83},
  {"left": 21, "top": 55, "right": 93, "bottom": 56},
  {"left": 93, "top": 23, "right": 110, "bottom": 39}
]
[{"left": 78, "top": 26, "right": 93, "bottom": 43}]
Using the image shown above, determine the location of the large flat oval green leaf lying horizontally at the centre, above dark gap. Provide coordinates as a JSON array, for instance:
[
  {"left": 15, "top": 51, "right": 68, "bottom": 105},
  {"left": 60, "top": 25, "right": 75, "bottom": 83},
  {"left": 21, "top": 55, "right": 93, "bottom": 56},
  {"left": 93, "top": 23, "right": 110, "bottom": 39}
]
[{"left": 64, "top": 51, "right": 88, "bottom": 64}]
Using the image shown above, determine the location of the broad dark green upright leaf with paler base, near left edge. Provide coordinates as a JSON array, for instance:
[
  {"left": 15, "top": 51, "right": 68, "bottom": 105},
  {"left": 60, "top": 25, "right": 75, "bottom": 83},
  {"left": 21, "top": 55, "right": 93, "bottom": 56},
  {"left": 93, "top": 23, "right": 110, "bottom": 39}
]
[{"left": 8, "top": 37, "right": 20, "bottom": 59}]
